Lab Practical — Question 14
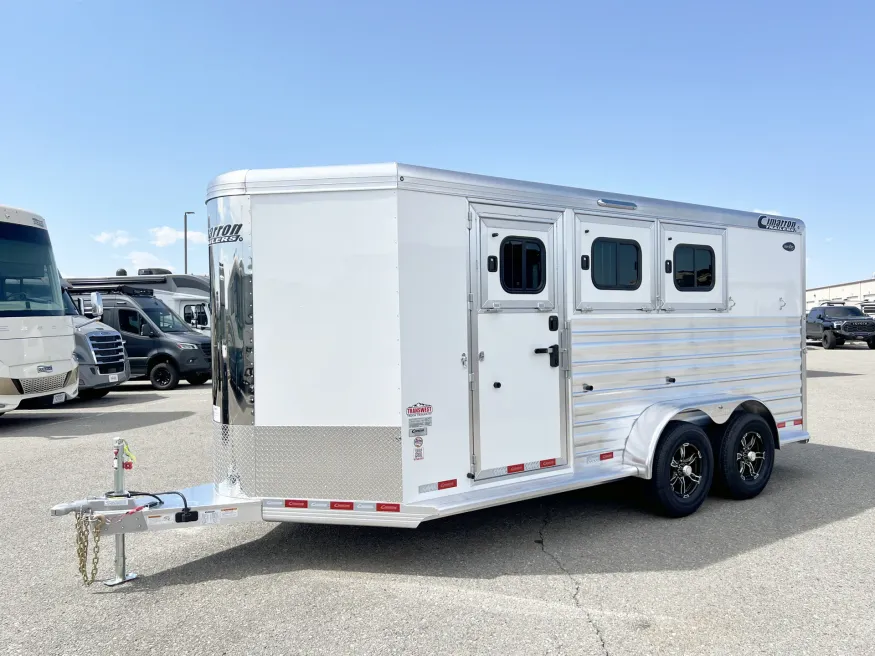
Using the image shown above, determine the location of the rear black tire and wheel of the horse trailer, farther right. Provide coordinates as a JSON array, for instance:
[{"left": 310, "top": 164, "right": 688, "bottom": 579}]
[{"left": 714, "top": 413, "right": 775, "bottom": 499}]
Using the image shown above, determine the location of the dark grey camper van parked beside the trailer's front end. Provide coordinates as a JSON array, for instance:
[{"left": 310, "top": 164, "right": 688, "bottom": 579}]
[{"left": 72, "top": 285, "right": 212, "bottom": 390}]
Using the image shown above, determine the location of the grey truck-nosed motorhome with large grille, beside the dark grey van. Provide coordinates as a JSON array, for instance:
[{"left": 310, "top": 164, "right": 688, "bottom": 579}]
[{"left": 61, "top": 279, "right": 131, "bottom": 399}]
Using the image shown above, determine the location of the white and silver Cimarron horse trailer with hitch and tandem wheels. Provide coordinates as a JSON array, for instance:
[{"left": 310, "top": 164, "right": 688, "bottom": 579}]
[{"left": 53, "top": 164, "right": 809, "bottom": 580}]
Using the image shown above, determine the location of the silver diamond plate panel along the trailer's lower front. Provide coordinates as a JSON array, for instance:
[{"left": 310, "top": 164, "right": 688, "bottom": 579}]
[{"left": 214, "top": 424, "right": 402, "bottom": 501}]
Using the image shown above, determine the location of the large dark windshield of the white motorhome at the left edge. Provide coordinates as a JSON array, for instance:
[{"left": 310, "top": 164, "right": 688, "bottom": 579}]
[{"left": 0, "top": 222, "right": 64, "bottom": 317}]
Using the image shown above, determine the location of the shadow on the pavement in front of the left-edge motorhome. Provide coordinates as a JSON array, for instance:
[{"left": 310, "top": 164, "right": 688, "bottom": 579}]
[{"left": 0, "top": 410, "right": 195, "bottom": 440}]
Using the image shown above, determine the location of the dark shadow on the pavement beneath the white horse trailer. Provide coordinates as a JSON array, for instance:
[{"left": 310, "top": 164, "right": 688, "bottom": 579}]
[{"left": 121, "top": 445, "right": 875, "bottom": 592}]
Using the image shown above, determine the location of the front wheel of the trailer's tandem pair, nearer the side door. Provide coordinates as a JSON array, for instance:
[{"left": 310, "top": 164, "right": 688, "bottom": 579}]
[{"left": 650, "top": 421, "right": 714, "bottom": 517}]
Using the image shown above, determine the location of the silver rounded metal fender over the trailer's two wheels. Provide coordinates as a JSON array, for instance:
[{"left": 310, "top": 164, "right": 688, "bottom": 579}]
[{"left": 623, "top": 396, "right": 777, "bottom": 479}]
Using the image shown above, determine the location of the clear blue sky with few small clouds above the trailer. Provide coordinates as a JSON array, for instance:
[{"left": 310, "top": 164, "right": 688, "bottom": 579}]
[{"left": 0, "top": 0, "right": 875, "bottom": 286}]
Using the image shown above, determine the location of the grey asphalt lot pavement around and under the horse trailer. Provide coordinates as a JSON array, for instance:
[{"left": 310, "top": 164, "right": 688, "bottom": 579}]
[{"left": 0, "top": 346, "right": 875, "bottom": 656}]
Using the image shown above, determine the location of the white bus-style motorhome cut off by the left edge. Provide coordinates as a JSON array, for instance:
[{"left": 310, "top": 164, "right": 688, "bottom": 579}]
[{"left": 0, "top": 206, "right": 79, "bottom": 414}]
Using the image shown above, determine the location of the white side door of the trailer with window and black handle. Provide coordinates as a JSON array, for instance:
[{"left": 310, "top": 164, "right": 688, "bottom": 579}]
[{"left": 471, "top": 205, "right": 567, "bottom": 479}]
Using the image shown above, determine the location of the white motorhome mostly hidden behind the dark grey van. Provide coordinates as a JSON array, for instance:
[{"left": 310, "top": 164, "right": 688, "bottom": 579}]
[{"left": 69, "top": 269, "right": 210, "bottom": 333}]
